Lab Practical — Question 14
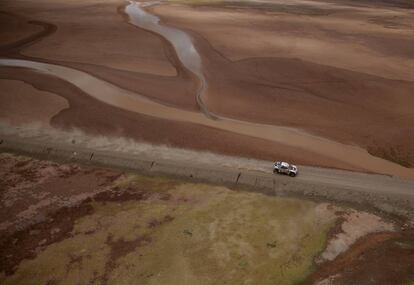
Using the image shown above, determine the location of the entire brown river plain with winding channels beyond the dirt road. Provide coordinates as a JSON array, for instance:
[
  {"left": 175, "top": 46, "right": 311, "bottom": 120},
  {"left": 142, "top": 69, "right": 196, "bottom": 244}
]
[{"left": 0, "top": 0, "right": 414, "bottom": 177}]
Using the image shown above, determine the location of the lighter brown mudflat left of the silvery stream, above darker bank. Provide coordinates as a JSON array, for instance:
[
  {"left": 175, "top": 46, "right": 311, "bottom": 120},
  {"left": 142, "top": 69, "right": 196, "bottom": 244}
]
[{"left": 1, "top": 0, "right": 176, "bottom": 76}]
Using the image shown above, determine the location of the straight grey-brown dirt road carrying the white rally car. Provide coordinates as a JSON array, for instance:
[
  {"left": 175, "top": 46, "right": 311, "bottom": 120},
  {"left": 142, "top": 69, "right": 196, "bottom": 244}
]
[{"left": 0, "top": 135, "right": 414, "bottom": 221}]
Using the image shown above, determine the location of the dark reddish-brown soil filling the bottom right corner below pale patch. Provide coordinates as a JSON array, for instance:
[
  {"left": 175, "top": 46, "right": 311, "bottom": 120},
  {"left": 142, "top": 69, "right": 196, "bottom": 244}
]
[{"left": 303, "top": 231, "right": 414, "bottom": 285}]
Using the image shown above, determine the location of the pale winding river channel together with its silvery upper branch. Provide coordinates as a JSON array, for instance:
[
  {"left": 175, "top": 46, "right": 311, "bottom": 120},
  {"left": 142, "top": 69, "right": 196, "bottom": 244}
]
[{"left": 0, "top": 2, "right": 414, "bottom": 177}]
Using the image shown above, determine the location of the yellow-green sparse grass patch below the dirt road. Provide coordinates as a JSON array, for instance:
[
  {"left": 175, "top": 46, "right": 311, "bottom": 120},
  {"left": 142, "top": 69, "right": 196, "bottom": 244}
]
[{"left": 0, "top": 175, "right": 336, "bottom": 285}]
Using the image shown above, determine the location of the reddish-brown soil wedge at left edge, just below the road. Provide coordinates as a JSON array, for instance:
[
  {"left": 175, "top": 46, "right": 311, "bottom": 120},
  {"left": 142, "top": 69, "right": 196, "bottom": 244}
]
[{"left": 0, "top": 154, "right": 119, "bottom": 235}]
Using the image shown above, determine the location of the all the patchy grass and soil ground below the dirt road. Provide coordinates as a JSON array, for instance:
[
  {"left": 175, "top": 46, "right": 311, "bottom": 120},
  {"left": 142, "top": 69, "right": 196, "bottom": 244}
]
[{"left": 0, "top": 154, "right": 414, "bottom": 284}]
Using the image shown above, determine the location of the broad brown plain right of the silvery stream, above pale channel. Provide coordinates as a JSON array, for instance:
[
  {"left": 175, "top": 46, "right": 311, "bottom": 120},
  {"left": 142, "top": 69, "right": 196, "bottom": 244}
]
[{"left": 151, "top": 3, "right": 414, "bottom": 167}]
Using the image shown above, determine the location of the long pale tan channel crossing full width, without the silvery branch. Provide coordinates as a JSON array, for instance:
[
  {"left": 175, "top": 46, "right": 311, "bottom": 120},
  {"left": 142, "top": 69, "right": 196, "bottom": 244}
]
[{"left": 0, "top": 59, "right": 414, "bottom": 177}]
